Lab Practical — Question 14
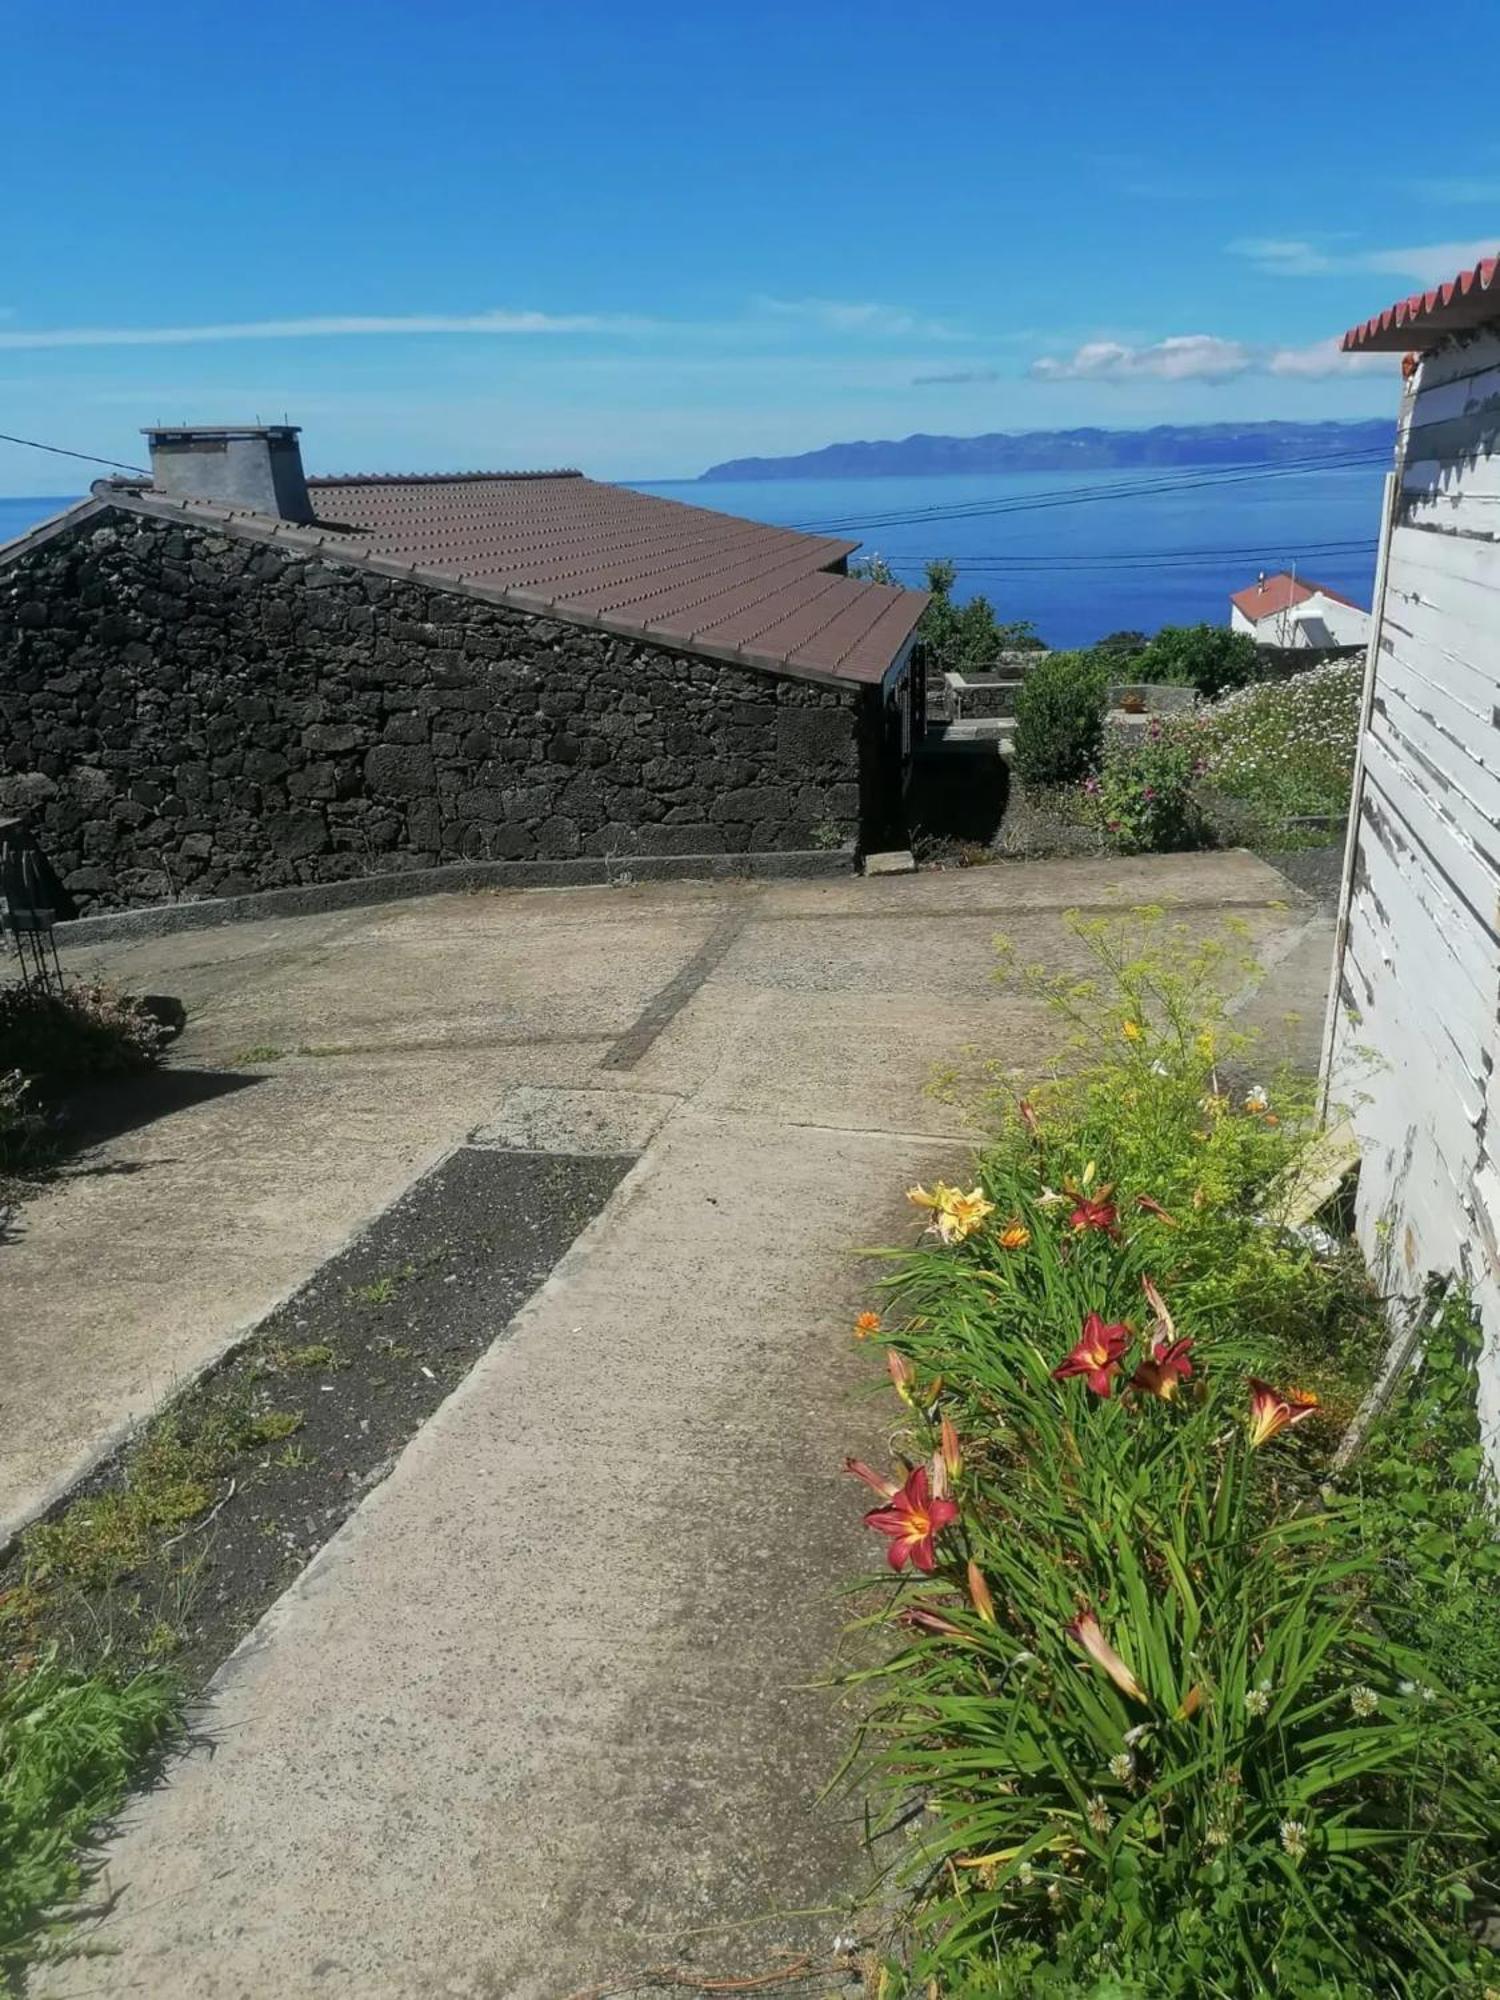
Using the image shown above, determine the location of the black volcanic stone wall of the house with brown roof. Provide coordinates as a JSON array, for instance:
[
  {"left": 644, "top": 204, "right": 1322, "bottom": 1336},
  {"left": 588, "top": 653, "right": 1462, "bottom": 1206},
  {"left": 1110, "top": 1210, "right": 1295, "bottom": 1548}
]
[{"left": 0, "top": 508, "right": 868, "bottom": 910}]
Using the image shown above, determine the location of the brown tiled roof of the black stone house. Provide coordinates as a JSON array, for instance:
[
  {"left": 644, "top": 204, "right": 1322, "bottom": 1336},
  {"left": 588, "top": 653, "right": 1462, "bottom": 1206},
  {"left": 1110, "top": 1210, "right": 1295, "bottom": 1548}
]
[{"left": 308, "top": 472, "right": 926, "bottom": 682}]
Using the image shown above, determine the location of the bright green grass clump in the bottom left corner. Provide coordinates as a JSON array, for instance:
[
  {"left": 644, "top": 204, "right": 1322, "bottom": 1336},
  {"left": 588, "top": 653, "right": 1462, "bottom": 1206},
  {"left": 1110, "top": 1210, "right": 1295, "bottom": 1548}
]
[{"left": 0, "top": 1656, "right": 178, "bottom": 1978}]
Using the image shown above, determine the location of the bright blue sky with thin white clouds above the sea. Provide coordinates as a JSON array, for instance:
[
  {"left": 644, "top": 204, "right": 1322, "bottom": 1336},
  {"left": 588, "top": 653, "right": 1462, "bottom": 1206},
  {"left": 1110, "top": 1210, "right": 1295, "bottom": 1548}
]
[{"left": 0, "top": 0, "right": 1500, "bottom": 494}]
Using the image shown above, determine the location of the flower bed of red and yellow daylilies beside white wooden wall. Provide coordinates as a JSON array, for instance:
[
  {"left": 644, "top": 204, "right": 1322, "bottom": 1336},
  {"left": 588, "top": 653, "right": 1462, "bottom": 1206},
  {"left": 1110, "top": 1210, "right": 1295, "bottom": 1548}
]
[{"left": 852, "top": 916, "right": 1500, "bottom": 2000}]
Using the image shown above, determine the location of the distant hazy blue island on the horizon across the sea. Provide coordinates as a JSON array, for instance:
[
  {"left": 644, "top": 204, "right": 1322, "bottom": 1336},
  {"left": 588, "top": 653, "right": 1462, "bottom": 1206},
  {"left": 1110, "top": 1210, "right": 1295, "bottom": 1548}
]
[{"left": 698, "top": 416, "right": 1396, "bottom": 480}]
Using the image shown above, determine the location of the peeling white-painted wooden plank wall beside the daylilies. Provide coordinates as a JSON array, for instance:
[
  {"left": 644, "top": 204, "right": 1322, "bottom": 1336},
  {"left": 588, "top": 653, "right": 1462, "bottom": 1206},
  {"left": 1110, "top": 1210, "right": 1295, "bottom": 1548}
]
[{"left": 1326, "top": 328, "right": 1500, "bottom": 1458}]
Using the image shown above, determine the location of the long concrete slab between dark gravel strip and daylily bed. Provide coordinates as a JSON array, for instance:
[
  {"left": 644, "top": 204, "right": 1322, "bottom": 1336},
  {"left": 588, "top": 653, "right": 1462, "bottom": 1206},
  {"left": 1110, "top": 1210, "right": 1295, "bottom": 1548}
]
[{"left": 36, "top": 1112, "right": 944, "bottom": 2000}]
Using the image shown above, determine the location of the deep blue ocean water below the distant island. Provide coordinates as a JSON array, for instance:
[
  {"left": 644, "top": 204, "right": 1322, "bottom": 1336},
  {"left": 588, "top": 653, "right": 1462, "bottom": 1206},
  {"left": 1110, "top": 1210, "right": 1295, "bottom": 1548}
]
[{"left": 0, "top": 464, "right": 1384, "bottom": 646}]
